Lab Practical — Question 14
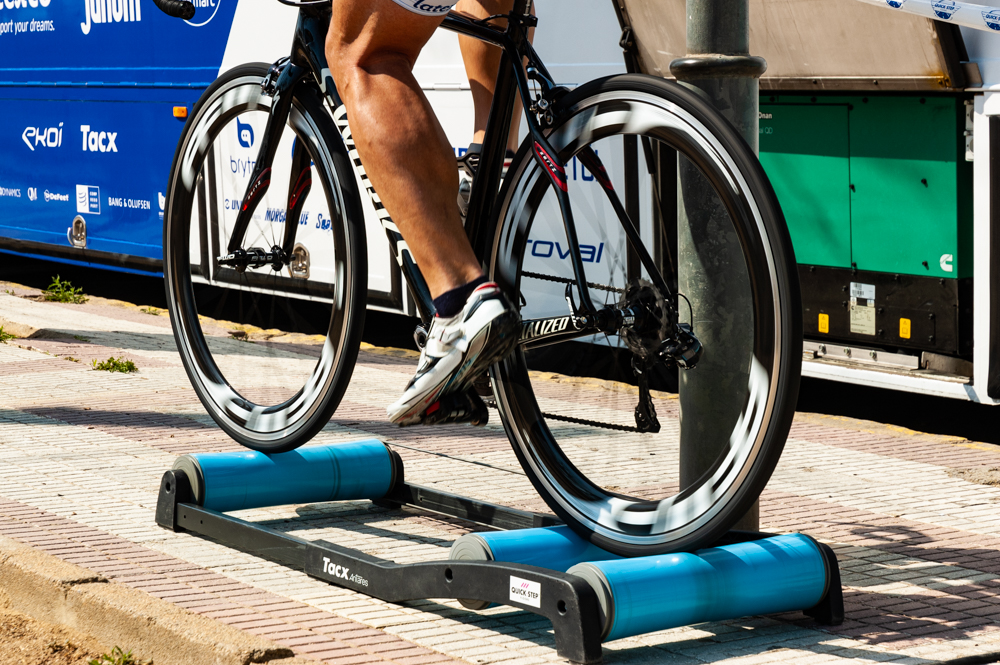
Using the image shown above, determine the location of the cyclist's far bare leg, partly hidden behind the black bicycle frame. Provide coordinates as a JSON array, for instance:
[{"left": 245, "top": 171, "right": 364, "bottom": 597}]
[{"left": 455, "top": 0, "right": 534, "bottom": 152}]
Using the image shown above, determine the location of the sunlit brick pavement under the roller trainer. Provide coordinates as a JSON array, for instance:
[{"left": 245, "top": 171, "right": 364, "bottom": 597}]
[{"left": 0, "top": 286, "right": 1000, "bottom": 665}]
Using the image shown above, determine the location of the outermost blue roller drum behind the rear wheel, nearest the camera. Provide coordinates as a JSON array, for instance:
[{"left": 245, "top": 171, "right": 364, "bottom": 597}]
[{"left": 568, "top": 534, "right": 829, "bottom": 641}]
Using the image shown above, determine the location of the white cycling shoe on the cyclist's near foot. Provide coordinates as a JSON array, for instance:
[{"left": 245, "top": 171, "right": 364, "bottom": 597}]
[{"left": 387, "top": 282, "right": 521, "bottom": 425}]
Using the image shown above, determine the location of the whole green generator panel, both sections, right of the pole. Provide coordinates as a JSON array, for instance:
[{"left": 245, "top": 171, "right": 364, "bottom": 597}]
[{"left": 760, "top": 94, "right": 972, "bottom": 278}]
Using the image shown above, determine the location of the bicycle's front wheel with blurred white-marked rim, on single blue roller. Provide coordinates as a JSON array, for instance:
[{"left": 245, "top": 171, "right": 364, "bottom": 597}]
[{"left": 163, "top": 63, "right": 368, "bottom": 453}]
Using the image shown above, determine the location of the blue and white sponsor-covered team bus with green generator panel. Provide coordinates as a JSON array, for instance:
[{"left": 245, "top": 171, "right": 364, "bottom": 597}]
[{"left": 0, "top": 0, "right": 1000, "bottom": 404}]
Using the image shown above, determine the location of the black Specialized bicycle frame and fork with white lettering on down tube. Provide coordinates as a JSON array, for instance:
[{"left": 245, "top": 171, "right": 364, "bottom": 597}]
[{"left": 224, "top": 0, "right": 671, "bottom": 332}]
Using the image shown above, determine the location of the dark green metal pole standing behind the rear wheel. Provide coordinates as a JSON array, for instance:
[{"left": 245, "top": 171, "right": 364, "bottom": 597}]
[{"left": 670, "top": 0, "right": 766, "bottom": 530}]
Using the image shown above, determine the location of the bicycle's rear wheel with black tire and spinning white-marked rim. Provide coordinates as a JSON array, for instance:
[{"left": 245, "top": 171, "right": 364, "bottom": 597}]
[{"left": 490, "top": 75, "right": 802, "bottom": 556}]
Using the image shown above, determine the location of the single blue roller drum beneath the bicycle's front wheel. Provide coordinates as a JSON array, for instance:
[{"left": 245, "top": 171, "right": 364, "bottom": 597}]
[{"left": 173, "top": 439, "right": 396, "bottom": 512}]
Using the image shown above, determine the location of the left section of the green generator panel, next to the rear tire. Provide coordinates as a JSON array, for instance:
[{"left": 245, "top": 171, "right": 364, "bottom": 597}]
[{"left": 760, "top": 100, "right": 851, "bottom": 268}]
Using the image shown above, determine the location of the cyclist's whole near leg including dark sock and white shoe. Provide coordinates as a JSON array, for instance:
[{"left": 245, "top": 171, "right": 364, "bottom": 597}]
[{"left": 326, "top": 0, "right": 520, "bottom": 425}]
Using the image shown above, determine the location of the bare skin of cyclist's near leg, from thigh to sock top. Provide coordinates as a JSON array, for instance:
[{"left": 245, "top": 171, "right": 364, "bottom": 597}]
[{"left": 326, "top": 0, "right": 482, "bottom": 297}]
